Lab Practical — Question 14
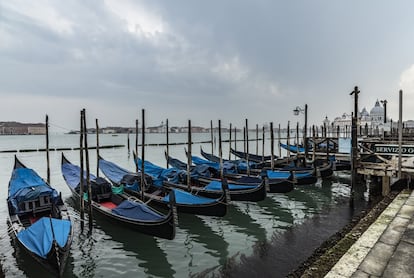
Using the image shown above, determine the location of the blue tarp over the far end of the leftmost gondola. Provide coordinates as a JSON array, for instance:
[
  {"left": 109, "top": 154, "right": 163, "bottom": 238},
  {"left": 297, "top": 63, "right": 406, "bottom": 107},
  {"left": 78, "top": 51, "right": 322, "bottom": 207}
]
[{"left": 9, "top": 168, "right": 59, "bottom": 212}]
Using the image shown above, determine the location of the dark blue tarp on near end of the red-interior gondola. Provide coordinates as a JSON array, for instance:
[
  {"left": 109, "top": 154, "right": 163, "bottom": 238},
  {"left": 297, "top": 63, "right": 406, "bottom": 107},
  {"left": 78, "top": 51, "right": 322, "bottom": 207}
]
[{"left": 112, "top": 200, "right": 165, "bottom": 221}]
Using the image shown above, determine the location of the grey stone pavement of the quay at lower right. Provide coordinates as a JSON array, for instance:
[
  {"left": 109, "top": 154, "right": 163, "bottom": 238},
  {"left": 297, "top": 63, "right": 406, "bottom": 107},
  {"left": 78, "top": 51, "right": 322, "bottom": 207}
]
[{"left": 325, "top": 190, "right": 414, "bottom": 278}]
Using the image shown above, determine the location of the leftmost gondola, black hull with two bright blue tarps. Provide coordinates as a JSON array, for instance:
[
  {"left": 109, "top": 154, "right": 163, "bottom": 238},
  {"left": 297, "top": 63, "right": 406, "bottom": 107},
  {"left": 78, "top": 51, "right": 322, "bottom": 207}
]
[{"left": 7, "top": 156, "right": 73, "bottom": 277}]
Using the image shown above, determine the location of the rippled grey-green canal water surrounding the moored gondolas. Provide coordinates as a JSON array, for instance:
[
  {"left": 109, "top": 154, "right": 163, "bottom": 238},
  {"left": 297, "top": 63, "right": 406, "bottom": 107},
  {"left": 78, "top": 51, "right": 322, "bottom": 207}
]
[{"left": 0, "top": 134, "right": 367, "bottom": 277}]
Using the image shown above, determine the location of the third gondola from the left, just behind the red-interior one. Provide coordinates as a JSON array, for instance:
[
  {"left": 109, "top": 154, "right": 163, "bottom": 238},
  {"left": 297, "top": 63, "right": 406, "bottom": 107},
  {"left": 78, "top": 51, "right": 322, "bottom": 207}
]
[{"left": 98, "top": 154, "right": 228, "bottom": 216}]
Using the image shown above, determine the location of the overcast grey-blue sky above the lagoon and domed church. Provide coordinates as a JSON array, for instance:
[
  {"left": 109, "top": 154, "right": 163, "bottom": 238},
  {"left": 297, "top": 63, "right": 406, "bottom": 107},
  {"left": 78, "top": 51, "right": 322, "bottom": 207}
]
[{"left": 0, "top": 0, "right": 414, "bottom": 131}]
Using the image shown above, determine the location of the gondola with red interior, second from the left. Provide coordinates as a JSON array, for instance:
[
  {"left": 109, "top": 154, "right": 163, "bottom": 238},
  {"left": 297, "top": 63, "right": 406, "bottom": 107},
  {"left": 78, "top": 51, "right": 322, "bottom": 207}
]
[{"left": 61, "top": 153, "right": 175, "bottom": 239}]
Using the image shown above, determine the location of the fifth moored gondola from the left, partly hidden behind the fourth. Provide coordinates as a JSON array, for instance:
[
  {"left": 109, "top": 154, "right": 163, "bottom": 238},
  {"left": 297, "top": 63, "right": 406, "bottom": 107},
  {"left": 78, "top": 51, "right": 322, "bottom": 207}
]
[{"left": 166, "top": 154, "right": 294, "bottom": 193}]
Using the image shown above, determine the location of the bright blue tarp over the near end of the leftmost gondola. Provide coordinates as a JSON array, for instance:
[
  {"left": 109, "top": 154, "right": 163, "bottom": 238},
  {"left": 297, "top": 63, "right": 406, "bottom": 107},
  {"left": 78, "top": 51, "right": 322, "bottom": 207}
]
[{"left": 17, "top": 217, "right": 71, "bottom": 258}]
